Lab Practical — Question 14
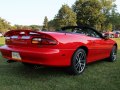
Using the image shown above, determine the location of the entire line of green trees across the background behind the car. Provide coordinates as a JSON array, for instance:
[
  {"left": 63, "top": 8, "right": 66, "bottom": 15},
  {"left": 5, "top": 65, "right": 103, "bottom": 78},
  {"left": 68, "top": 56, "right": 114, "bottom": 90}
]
[{"left": 0, "top": 0, "right": 120, "bottom": 32}]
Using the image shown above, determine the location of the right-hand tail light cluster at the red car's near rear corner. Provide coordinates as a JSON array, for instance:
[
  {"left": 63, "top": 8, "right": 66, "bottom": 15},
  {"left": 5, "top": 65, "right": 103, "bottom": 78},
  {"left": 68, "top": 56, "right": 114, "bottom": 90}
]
[{"left": 32, "top": 38, "right": 57, "bottom": 45}]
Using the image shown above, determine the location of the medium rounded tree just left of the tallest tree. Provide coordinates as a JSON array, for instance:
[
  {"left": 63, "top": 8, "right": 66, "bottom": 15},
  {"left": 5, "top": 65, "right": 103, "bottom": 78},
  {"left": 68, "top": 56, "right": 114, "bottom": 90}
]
[{"left": 53, "top": 5, "right": 76, "bottom": 28}]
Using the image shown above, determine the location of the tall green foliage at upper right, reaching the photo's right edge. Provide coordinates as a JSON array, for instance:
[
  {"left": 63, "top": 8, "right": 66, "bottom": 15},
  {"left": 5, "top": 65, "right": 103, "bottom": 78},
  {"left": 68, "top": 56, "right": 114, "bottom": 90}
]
[{"left": 72, "top": 0, "right": 120, "bottom": 31}]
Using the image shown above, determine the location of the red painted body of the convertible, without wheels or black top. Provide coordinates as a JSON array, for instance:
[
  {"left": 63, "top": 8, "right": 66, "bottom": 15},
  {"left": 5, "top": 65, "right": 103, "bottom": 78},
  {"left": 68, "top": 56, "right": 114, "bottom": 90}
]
[{"left": 0, "top": 25, "right": 117, "bottom": 74}]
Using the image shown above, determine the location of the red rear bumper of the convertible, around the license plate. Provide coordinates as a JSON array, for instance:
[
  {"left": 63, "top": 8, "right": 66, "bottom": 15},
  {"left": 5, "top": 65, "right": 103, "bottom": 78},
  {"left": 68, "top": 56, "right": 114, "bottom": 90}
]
[{"left": 0, "top": 45, "right": 74, "bottom": 66}]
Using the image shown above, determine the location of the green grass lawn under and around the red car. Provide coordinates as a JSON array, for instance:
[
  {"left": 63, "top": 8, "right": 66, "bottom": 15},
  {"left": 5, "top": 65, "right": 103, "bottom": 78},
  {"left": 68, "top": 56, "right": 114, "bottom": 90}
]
[{"left": 0, "top": 38, "right": 120, "bottom": 90}]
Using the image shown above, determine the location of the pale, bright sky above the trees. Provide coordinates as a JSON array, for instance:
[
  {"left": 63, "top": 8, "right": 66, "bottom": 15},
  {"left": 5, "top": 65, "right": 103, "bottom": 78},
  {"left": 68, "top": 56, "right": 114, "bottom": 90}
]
[{"left": 0, "top": 0, "right": 120, "bottom": 25}]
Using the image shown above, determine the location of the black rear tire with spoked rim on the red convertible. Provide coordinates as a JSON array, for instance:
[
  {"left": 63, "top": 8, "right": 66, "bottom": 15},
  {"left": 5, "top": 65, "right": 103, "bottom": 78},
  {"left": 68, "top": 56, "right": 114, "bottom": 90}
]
[{"left": 69, "top": 48, "right": 86, "bottom": 75}]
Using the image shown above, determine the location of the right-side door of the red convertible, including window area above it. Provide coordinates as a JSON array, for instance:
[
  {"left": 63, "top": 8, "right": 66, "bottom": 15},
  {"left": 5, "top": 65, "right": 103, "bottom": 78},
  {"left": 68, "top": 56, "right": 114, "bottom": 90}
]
[{"left": 86, "top": 28, "right": 111, "bottom": 62}]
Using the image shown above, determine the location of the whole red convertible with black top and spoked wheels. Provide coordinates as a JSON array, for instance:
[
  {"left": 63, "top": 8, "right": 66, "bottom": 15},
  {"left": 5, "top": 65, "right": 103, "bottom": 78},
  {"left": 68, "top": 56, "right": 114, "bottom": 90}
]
[{"left": 0, "top": 26, "right": 117, "bottom": 74}]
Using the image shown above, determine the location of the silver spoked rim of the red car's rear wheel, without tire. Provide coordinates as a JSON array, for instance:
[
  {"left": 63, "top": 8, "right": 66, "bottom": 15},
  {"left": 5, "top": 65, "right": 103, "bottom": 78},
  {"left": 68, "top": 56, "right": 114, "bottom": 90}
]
[{"left": 75, "top": 52, "right": 86, "bottom": 73}]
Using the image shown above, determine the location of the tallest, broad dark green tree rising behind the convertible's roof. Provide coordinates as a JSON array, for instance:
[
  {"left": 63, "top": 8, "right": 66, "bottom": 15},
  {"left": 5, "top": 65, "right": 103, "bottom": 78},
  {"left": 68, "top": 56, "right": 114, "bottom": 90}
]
[{"left": 73, "top": 0, "right": 105, "bottom": 27}]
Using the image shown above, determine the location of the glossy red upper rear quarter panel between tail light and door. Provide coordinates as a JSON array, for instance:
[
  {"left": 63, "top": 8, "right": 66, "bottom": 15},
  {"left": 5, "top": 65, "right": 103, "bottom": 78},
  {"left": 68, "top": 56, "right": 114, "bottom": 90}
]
[{"left": 47, "top": 33, "right": 88, "bottom": 50}]
